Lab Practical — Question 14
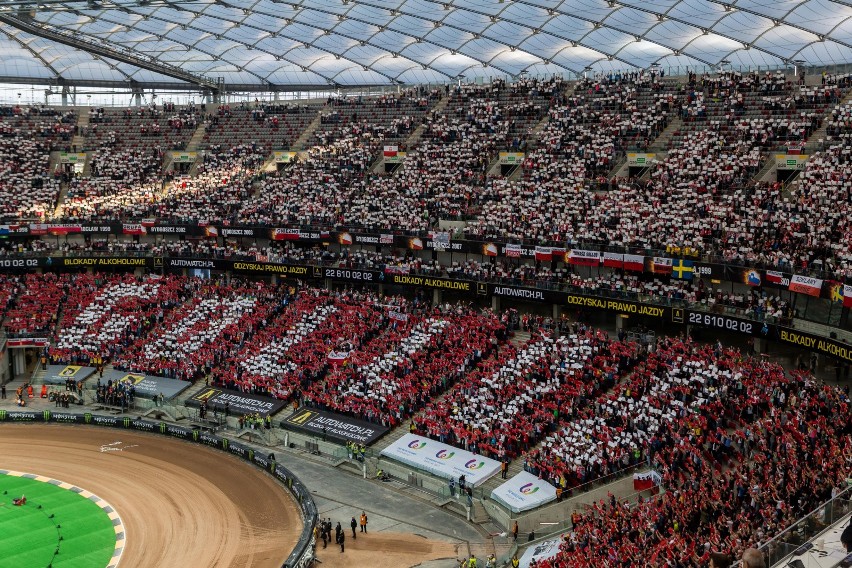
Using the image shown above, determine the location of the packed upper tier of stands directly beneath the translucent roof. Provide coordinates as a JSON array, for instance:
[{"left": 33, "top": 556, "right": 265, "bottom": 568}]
[{"left": 5, "top": 73, "right": 852, "bottom": 277}]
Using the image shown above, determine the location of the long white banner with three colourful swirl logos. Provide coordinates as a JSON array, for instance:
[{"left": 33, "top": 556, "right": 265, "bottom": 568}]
[{"left": 382, "top": 434, "right": 500, "bottom": 487}]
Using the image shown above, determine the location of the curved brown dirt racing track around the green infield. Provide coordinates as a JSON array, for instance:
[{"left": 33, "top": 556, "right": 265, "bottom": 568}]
[{"left": 0, "top": 424, "right": 302, "bottom": 568}]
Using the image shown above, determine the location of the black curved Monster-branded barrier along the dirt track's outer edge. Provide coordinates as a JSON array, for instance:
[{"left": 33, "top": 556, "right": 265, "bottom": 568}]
[{"left": 0, "top": 410, "right": 318, "bottom": 568}]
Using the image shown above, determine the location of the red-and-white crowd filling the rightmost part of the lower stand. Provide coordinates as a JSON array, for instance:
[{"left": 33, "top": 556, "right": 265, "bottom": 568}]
[{"left": 532, "top": 339, "right": 852, "bottom": 568}]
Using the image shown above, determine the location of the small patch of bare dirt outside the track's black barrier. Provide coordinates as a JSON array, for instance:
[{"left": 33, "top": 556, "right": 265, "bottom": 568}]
[{"left": 316, "top": 530, "right": 462, "bottom": 568}]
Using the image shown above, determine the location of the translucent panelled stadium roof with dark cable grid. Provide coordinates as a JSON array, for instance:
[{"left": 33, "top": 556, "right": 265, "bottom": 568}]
[{"left": 0, "top": 0, "right": 852, "bottom": 90}]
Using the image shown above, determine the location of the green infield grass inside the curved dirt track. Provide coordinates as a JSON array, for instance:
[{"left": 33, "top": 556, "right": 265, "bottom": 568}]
[{"left": 0, "top": 475, "right": 116, "bottom": 568}]
